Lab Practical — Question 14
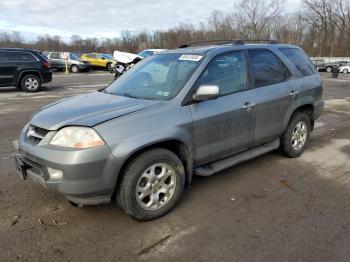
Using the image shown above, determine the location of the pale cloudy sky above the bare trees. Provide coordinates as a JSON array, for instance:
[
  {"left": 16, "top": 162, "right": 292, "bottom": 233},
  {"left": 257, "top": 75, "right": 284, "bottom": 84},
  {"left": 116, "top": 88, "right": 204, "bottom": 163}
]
[{"left": 0, "top": 0, "right": 301, "bottom": 41}]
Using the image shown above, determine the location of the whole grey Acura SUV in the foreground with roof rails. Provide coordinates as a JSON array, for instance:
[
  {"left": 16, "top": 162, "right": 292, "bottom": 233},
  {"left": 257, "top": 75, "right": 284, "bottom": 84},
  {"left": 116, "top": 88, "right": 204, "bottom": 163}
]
[{"left": 16, "top": 42, "right": 324, "bottom": 220}]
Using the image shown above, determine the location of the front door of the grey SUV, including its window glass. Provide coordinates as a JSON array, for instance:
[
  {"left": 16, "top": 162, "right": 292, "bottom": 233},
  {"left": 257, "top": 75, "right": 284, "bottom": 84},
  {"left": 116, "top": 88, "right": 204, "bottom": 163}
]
[{"left": 191, "top": 51, "right": 255, "bottom": 165}]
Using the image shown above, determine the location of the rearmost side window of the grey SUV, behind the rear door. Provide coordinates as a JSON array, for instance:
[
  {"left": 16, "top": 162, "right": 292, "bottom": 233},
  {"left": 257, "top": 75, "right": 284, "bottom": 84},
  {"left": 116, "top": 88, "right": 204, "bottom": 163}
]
[{"left": 279, "top": 48, "right": 316, "bottom": 76}]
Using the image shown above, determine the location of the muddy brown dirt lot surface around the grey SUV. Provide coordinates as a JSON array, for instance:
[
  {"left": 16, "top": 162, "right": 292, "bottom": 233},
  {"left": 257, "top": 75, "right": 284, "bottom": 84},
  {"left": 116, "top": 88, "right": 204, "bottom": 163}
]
[{"left": 0, "top": 72, "right": 350, "bottom": 262}]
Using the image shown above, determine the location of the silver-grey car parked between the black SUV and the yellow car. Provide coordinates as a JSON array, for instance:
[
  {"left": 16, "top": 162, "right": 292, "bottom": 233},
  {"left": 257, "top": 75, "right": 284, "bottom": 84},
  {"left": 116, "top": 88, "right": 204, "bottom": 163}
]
[{"left": 45, "top": 52, "right": 90, "bottom": 73}]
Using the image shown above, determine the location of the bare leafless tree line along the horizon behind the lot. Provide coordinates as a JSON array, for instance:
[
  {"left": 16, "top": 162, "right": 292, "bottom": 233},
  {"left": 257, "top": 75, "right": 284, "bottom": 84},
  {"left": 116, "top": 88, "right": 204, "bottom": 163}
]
[{"left": 0, "top": 0, "right": 350, "bottom": 57}]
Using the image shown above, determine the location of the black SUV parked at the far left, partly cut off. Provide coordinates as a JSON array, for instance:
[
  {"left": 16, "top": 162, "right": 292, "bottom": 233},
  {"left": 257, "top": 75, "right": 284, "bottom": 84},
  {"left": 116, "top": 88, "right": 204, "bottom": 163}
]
[{"left": 0, "top": 48, "right": 52, "bottom": 92}]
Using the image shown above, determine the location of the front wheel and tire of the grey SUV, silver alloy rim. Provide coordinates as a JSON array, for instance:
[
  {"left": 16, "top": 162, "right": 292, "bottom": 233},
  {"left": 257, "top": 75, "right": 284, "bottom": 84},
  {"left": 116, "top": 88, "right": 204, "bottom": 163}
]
[{"left": 117, "top": 148, "right": 185, "bottom": 221}]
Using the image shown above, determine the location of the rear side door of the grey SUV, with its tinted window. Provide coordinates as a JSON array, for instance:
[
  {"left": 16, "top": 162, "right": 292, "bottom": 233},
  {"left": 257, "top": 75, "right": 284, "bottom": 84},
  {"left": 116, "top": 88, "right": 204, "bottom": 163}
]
[{"left": 248, "top": 49, "right": 300, "bottom": 145}]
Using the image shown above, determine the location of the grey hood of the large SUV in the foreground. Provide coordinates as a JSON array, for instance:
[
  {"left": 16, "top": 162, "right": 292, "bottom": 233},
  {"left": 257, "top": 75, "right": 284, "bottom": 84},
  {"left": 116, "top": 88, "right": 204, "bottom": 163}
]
[{"left": 30, "top": 92, "right": 161, "bottom": 130}]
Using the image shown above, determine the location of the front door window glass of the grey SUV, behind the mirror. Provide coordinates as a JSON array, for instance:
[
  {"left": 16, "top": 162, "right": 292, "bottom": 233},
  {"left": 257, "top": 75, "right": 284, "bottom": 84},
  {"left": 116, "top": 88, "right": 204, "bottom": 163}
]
[{"left": 197, "top": 52, "right": 247, "bottom": 95}]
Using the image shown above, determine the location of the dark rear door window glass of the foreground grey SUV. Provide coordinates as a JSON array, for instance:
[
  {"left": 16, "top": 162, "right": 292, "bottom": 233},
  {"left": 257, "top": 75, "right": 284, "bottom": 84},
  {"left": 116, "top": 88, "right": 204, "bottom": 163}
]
[{"left": 248, "top": 50, "right": 291, "bottom": 87}]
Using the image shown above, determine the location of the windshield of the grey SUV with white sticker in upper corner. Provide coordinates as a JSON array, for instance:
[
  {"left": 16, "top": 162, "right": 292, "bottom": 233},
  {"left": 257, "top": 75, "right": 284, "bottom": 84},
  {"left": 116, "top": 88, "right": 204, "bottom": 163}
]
[{"left": 106, "top": 54, "right": 203, "bottom": 100}]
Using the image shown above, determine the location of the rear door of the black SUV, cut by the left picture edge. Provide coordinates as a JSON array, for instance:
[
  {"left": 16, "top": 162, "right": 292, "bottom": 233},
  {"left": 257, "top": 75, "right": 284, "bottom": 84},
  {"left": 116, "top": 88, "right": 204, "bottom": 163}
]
[{"left": 0, "top": 51, "right": 17, "bottom": 86}]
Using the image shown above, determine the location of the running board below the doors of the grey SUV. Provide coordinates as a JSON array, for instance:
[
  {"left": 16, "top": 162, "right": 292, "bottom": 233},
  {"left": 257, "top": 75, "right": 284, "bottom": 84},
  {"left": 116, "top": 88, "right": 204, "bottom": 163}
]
[{"left": 194, "top": 139, "right": 280, "bottom": 176}]
